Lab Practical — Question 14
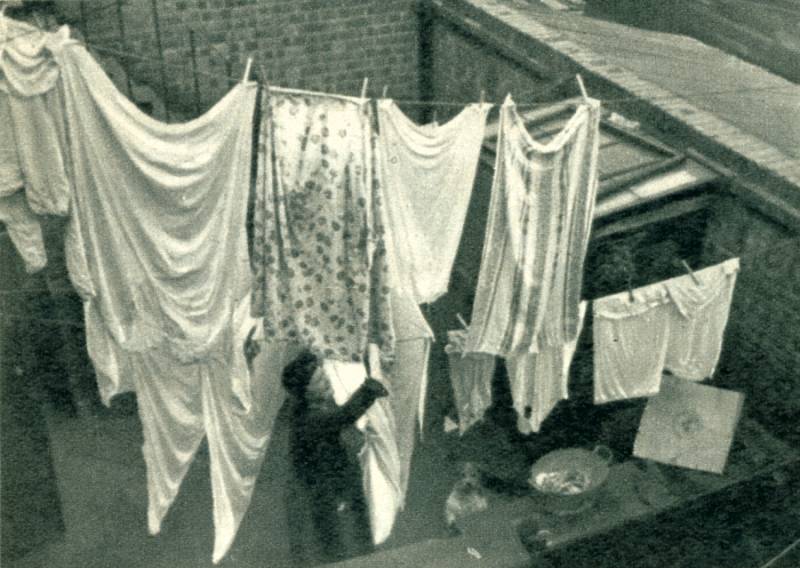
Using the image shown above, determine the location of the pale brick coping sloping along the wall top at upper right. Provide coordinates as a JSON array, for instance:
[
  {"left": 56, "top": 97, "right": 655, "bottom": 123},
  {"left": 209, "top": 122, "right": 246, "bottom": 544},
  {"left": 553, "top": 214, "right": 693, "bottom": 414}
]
[{"left": 432, "top": 0, "right": 800, "bottom": 229}]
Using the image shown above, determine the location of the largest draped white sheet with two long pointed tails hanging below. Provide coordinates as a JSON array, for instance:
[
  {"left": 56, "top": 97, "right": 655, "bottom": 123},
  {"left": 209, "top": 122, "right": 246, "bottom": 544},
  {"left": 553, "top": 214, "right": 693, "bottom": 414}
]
[{"left": 60, "top": 41, "right": 262, "bottom": 562}]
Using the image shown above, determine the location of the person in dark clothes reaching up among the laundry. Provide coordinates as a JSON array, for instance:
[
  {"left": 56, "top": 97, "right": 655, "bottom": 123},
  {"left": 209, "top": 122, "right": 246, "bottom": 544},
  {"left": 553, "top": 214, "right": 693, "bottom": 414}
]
[{"left": 283, "top": 352, "right": 388, "bottom": 566}]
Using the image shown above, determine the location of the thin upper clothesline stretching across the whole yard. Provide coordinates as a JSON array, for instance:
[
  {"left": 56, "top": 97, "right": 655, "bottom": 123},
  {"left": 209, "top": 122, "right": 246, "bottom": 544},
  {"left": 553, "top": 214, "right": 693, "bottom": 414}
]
[{"left": 5, "top": 23, "right": 797, "bottom": 113}]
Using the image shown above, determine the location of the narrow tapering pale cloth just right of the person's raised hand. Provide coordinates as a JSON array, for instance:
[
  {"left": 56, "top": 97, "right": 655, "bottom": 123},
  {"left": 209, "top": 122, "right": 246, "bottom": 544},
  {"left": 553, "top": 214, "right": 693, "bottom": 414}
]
[{"left": 389, "top": 294, "right": 433, "bottom": 506}]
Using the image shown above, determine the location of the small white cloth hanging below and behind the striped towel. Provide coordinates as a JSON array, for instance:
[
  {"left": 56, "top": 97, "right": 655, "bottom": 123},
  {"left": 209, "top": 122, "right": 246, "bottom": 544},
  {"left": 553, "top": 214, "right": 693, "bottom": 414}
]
[{"left": 506, "top": 302, "right": 586, "bottom": 434}]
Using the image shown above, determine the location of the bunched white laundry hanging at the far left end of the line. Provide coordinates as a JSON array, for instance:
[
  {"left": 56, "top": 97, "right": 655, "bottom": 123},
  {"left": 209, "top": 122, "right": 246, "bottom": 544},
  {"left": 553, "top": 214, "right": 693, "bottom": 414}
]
[{"left": 0, "top": 16, "right": 74, "bottom": 274}]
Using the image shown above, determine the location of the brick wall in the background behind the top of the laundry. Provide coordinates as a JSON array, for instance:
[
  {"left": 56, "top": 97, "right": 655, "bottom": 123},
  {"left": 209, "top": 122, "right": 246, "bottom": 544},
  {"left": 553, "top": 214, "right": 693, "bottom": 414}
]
[{"left": 57, "top": 0, "right": 418, "bottom": 116}]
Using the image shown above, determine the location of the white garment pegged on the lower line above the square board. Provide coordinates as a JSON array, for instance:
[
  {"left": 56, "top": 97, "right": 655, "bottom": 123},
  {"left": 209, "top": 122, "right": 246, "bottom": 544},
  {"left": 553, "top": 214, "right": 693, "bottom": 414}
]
[{"left": 593, "top": 259, "right": 739, "bottom": 404}]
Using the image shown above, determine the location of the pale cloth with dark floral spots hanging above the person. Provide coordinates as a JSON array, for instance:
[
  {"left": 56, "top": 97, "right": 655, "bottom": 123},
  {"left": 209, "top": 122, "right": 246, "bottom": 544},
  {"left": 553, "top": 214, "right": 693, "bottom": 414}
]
[{"left": 253, "top": 89, "right": 394, "bottom": 361}]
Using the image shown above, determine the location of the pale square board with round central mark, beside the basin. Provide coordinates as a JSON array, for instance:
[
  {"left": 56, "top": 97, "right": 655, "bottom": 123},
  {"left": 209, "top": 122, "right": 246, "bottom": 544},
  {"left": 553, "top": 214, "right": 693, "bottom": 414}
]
[{"left": 633, "top": 375, "right": 744, "bottom": 474}]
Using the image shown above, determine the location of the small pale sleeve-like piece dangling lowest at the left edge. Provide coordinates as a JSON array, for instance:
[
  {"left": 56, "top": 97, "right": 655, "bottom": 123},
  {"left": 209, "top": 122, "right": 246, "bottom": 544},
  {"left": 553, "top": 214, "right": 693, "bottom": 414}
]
[{"left": 0, "top": 188, "right": 47, "bottom": 274}]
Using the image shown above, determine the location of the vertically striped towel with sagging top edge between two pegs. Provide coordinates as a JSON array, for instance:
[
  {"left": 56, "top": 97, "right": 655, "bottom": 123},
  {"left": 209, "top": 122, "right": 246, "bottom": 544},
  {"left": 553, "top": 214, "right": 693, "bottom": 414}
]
[{"left": 466, "top": 97, "right": 600, "bottom": 356}]
